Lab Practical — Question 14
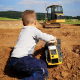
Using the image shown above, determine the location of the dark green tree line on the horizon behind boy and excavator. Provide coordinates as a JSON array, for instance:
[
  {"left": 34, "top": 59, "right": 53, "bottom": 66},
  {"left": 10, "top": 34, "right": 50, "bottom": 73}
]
[{"left": 0, "top": 11, "right": 80, "bottom": 20}]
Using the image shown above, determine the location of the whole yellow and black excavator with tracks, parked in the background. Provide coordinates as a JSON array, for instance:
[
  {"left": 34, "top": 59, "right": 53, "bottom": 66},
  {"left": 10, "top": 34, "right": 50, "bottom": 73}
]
[{"left": 43, "top": 5, "right": 65, "bottom": 28}]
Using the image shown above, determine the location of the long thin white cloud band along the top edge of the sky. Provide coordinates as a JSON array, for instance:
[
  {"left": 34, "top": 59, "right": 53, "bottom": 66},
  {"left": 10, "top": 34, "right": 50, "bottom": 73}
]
[{"left": 18, "top": 0, "right": 80, "bottom": 6}]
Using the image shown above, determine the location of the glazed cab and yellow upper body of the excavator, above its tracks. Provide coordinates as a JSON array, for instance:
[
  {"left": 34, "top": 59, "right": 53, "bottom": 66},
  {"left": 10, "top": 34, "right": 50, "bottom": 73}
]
[{"left": 46, "top": 5, "right": 65, "bottom": 23}]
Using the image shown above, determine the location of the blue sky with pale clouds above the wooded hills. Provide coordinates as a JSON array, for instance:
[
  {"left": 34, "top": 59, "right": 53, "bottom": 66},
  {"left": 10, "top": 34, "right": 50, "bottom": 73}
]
[{"left": 0, "top": 0, "right": 80, "bottom": 16}]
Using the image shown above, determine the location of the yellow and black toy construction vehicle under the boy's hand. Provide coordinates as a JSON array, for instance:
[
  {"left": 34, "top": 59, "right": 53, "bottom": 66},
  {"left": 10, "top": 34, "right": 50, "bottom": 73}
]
[{"left": 45, "top": 39, "right": 63, "bottom": 65}]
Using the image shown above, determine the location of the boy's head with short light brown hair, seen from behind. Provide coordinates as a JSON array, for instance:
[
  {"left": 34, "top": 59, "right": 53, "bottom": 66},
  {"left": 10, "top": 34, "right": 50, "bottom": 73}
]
[{"left": 22, "top": 10, "right": 36, "bottom": 26}]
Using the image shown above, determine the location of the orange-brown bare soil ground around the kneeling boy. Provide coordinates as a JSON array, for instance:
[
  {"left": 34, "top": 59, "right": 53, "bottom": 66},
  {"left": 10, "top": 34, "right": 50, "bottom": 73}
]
[{"left": 0, "top": 21, "right": 80, "bottom": 80}]
